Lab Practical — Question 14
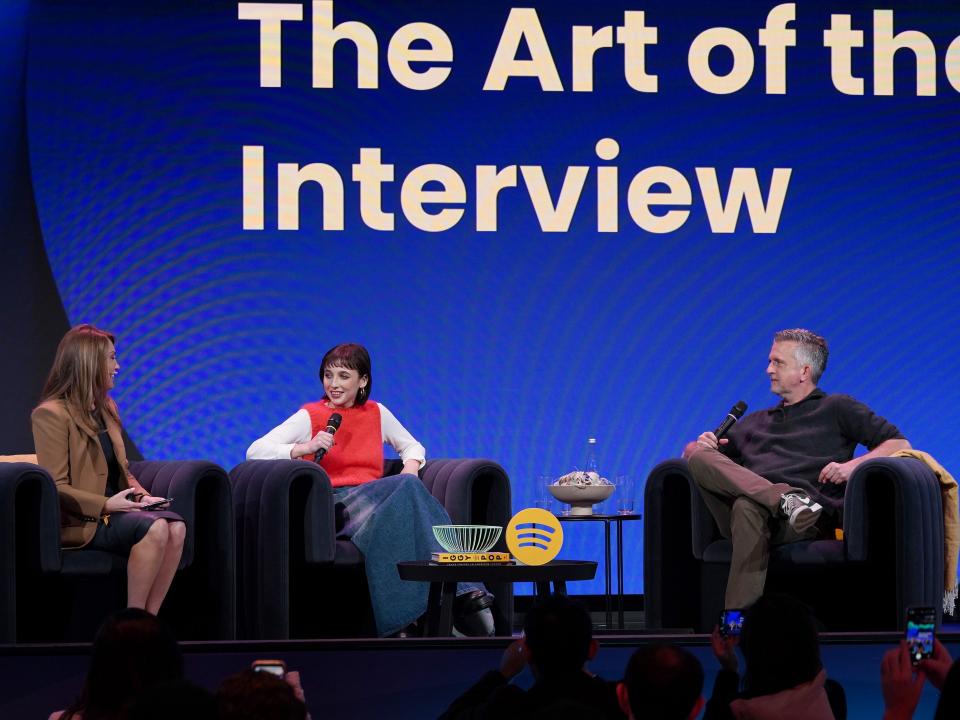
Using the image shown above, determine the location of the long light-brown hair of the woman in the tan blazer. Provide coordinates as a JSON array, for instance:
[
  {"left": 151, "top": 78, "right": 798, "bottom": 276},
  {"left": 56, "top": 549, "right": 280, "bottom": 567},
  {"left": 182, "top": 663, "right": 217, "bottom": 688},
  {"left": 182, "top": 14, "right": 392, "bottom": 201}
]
[{"left": 40, "top": 324, "right": 120, "bottom": 432}]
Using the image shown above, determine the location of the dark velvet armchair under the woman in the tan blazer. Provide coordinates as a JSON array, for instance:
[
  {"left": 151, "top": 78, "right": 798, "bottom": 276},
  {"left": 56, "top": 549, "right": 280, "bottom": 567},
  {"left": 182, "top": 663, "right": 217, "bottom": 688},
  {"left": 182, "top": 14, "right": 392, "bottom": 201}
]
[{"left": 0, "top": 461, "right": 236, "bottom": 643}]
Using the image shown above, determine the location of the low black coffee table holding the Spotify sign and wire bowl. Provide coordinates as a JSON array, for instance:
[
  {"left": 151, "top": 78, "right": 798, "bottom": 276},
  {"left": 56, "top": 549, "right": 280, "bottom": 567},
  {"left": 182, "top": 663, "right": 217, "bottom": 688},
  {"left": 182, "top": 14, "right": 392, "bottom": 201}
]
[{"left": 397, "top": 560, "right": 597, "bottom": 637}]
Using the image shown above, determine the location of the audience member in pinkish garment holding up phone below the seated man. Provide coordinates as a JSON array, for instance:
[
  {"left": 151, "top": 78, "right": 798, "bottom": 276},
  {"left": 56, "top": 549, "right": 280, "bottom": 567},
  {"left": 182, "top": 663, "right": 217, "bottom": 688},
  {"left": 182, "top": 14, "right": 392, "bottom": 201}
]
[{"left": 704, "top": 594, "right": 847, "bottom": 720}]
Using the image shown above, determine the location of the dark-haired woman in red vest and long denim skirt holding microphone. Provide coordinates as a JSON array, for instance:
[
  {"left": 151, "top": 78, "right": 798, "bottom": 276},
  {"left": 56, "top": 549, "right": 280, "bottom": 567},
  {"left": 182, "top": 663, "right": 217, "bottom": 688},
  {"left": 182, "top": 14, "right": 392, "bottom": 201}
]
[{"left": 247, "top": 343, "right": 493, "bottom": 636}]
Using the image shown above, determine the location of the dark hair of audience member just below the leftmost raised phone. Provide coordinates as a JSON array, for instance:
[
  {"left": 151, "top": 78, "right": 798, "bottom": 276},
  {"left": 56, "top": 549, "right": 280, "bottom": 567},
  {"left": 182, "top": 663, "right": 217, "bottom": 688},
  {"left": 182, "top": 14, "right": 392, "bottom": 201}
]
[{"left": 217, "top": 669, "right": 307, "bottom": 720}]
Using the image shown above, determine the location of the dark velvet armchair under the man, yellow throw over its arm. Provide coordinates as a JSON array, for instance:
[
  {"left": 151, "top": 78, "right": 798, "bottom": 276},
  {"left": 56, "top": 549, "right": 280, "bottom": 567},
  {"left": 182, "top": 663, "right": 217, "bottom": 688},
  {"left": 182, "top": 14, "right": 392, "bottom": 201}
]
[{"left": 643, "top": 458, "right": 944, "bottom": 632}]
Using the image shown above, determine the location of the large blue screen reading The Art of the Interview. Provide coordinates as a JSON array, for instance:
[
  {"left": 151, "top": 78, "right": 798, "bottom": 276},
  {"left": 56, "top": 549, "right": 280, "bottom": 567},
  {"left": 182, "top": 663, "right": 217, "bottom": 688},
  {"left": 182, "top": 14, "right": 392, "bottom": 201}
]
[{"left": 26, "top": 0, "right": 960, "bottom": 593}]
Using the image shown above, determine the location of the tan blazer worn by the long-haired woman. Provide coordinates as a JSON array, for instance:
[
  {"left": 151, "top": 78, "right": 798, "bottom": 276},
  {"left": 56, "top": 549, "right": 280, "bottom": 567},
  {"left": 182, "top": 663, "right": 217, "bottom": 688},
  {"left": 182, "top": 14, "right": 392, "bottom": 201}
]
[{"left": 30, "top": 400, "right": 144, "bottom": 548}]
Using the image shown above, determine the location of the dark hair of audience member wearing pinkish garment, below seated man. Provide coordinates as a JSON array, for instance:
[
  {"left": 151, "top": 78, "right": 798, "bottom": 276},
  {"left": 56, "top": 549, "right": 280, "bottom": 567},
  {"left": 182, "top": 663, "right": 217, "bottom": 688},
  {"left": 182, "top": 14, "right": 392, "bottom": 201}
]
[{"left": 740, "top": 593, "right": 823, "bottom": 697}]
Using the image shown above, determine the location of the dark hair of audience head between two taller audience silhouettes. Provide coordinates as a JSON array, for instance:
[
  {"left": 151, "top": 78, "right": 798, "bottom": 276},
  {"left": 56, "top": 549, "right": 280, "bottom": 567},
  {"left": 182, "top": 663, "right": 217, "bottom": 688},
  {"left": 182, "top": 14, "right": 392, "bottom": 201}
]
[{"left": 623, "top": 645, "right": 703, "bottom": 720}]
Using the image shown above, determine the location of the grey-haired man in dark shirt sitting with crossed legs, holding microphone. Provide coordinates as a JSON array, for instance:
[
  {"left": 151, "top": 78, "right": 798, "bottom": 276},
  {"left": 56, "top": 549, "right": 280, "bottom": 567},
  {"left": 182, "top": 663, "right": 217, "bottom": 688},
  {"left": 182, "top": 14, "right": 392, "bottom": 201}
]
[{"left": 683, "top": 329, "right": 910, "bottom": 608}]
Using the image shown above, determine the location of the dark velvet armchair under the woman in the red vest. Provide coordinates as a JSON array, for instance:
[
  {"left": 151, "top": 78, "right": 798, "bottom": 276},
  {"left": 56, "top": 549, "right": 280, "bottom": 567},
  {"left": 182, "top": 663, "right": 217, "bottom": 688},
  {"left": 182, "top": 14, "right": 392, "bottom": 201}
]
[{"left": 230, "top": 459, "right": 513, "bottom": 640}]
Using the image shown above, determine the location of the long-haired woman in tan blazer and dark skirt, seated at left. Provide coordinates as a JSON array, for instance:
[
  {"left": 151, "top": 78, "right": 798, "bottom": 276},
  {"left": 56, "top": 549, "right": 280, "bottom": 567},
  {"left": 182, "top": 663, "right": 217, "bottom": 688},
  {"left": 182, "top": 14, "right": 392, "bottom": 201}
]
[{"left": 31, "top": 325, "right": 186, "bottom": 614}]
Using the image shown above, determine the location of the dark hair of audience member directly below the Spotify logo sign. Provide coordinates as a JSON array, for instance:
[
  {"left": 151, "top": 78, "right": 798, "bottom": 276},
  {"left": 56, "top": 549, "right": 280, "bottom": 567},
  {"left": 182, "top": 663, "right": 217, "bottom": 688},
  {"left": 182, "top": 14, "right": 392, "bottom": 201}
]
[{"left": 523, "top": 595, "right": 593, "bottom": 675}]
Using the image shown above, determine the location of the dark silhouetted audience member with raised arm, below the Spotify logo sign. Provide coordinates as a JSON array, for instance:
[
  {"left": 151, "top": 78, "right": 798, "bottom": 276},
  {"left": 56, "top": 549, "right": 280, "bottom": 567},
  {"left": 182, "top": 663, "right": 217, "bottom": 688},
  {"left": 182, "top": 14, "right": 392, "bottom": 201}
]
[{"left": 441, "top": 595, "right": 624, "bottom": 720}]
